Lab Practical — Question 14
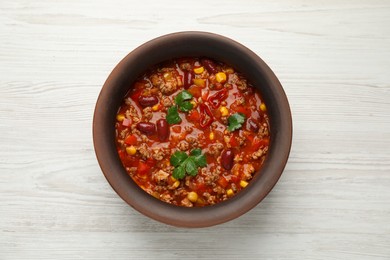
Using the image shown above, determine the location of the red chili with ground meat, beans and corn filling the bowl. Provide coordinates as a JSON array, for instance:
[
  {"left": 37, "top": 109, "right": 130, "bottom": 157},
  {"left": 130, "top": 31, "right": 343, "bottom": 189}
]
[{"left": 115, "top": 58, "right": 270, "bottom": 207}]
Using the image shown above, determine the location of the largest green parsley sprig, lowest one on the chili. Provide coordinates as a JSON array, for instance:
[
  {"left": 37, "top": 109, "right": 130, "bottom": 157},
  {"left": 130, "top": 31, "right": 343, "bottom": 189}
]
[{"left": 170, "top": 148, "right": 207, "bottom": 179}]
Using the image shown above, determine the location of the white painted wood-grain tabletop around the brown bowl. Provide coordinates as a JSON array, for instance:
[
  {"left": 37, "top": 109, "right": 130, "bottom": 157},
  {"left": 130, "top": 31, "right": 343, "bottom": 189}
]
[{"left": 0, "top": 0, "right": 390, "bottom": 259}]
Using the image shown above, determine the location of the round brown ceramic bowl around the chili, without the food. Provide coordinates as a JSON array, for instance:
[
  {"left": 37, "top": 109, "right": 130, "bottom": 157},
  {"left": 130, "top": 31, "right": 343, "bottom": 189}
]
[{"left": 93, "top": 32, "right": 292, "bottom": 227}]
